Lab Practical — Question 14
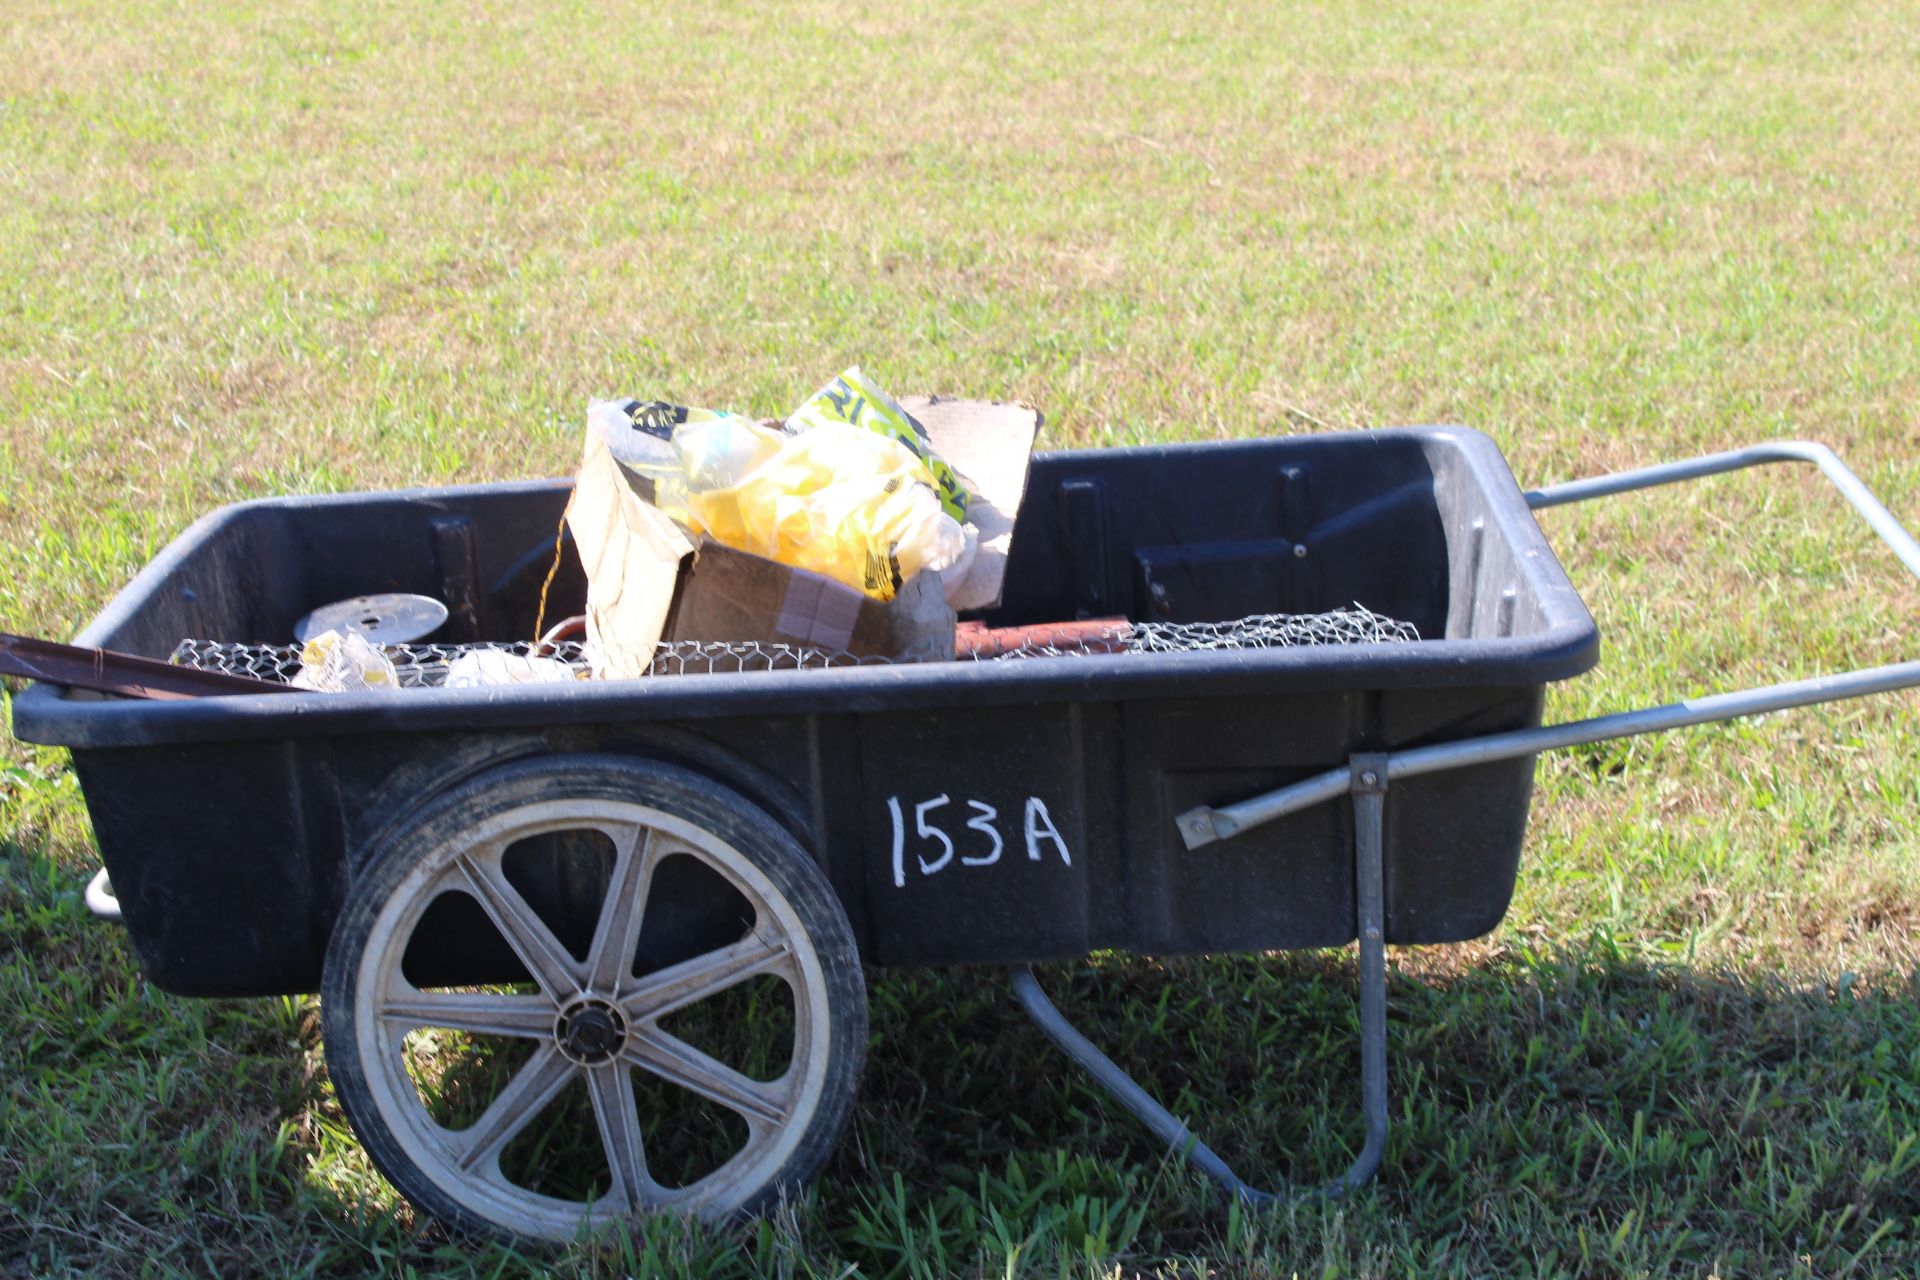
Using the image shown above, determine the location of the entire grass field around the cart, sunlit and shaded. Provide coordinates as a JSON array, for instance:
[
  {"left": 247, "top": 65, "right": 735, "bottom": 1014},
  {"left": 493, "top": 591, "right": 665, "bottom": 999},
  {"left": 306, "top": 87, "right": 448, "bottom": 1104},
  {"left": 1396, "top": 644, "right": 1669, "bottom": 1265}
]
[{"left": 0, "top": 0, "right": 1920, "bottom": 1276}]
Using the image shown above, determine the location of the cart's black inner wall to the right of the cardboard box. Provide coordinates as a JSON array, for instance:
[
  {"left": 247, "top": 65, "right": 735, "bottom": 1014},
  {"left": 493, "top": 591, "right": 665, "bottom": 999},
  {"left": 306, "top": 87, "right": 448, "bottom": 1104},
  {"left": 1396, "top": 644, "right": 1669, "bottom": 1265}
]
[{"left": 987, "top": 434, "right": 1549, "bottom": 639}]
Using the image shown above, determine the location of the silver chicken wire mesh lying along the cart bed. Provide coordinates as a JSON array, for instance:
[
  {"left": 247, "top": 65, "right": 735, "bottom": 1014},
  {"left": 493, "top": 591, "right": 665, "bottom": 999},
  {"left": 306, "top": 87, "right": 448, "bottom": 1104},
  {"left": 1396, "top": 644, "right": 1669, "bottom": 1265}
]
[{"left": 171, "top": 604, "right": 1421, "bottom": 689}]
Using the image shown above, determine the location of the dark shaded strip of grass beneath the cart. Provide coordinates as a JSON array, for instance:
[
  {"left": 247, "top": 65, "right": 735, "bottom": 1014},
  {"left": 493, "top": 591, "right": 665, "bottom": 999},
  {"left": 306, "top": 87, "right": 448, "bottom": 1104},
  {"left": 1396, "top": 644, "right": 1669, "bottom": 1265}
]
[{"left": 0, "top": 821, "right": 1920, "bottom": 1276}]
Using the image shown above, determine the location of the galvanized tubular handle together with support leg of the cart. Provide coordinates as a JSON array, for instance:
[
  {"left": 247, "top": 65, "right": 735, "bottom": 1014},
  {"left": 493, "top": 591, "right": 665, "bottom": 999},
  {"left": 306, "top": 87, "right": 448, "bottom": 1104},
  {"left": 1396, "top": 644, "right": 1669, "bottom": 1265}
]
[{"left": 1014, "top": 441, "right": 1920, "bottom": 1203}]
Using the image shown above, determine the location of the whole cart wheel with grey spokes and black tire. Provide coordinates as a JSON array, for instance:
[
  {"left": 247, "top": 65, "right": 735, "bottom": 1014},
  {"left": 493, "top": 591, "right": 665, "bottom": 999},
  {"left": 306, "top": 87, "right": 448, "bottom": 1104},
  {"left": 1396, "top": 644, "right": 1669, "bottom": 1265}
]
[{"left": 321, "top": 756, "right": 866, "bottom": 1240}]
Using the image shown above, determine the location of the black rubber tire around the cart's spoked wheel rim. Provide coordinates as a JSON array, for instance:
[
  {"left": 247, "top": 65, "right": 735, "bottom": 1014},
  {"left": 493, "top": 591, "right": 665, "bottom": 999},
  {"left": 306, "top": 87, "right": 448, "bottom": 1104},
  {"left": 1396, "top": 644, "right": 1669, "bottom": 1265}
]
[{"left": 321, "top": 754, "right": 868, "bottom": 1240}]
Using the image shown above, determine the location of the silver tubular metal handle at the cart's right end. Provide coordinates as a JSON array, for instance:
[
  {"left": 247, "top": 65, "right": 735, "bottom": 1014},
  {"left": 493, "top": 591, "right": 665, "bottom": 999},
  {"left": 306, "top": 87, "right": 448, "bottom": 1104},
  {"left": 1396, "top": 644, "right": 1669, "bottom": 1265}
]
[{"left": 1173, "top": 439, "right": 1920, "bottom": 848}]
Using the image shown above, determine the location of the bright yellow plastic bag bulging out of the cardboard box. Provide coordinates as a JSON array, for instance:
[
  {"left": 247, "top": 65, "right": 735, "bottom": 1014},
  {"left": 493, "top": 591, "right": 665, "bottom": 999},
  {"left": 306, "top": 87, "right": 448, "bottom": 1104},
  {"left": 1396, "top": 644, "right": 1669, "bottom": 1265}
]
[{"left": 674, "top": 422, "right": 966, "bottom": 601}]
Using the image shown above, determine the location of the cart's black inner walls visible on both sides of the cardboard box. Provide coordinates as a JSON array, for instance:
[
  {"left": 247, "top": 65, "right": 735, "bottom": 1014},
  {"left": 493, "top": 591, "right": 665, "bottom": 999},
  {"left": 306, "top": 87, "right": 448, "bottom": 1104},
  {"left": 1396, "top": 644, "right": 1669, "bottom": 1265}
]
[{"left": 82, "top": 434, "right": 1578, "bottom": 656}]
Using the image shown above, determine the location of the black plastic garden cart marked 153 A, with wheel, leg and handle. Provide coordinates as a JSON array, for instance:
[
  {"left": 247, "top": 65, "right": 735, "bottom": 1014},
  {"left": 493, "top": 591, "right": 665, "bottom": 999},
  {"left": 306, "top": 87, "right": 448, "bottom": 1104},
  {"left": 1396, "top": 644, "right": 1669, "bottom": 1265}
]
[{"left": 15, "top": 428, "right": 1920, "bottom": 1236}]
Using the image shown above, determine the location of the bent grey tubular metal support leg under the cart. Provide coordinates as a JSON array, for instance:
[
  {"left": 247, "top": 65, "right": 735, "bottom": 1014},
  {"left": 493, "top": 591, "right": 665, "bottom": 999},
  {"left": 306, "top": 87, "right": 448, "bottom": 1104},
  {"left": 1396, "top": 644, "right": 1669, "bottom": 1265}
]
[{"left": 1014, "top": 754, "right": 1388, "bottom": 1205}]
